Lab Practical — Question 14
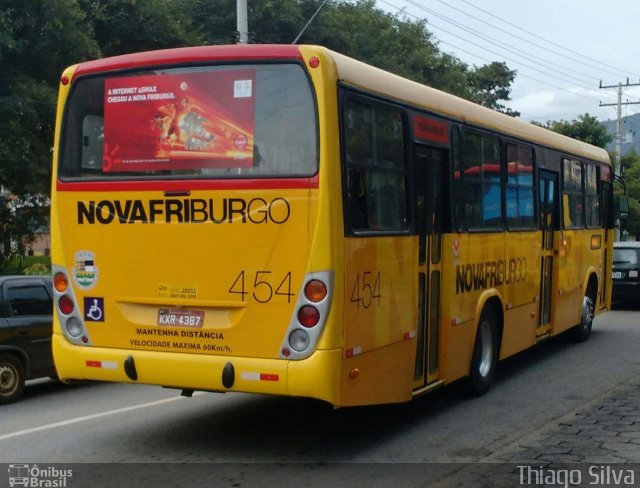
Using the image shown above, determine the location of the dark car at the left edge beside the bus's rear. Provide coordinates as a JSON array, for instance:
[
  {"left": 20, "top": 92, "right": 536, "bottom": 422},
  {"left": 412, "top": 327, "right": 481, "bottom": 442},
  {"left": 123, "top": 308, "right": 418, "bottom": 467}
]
[{"left": 0, "top": 276, "right": 56, "bottom": 404}]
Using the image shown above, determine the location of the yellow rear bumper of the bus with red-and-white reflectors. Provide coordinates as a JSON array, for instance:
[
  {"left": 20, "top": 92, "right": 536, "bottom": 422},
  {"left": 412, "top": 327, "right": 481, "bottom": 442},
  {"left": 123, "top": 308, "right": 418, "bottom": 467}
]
[{"left": 52, "top": 334, "right": 342, "bottom": 405}]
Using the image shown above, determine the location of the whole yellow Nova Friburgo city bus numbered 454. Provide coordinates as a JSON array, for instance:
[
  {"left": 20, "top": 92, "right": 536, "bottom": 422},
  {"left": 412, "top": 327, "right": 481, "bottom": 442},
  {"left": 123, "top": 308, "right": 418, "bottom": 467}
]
[{"left": 51, "top": 45, "right": 613, "bottom": 406}]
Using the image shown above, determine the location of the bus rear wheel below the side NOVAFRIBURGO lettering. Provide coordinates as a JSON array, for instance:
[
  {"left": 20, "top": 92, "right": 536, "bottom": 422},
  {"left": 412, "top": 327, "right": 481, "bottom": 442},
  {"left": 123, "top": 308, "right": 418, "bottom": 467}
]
[{"left": 469, "top": 306, "right": 498, "bottom": 395}]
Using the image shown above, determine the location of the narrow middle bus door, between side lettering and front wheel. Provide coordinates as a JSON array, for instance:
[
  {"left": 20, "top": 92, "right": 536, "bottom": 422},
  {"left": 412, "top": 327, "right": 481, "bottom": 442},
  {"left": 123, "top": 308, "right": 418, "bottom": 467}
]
[{"left": 536, "top": 170, "right": 560, "bottom": 336}]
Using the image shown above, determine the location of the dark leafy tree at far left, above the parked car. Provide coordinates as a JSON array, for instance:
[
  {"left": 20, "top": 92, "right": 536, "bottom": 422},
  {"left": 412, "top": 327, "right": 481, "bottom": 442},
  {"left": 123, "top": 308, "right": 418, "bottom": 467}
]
[{"left": 0, "top": 0, "right": 99, "bottom": 253}]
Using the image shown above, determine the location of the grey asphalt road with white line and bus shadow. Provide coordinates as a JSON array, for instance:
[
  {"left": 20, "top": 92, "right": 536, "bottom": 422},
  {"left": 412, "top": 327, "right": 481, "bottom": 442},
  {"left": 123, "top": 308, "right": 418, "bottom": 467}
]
[{"left": 0, "top": 309, "right": 640, "bottom": 486}]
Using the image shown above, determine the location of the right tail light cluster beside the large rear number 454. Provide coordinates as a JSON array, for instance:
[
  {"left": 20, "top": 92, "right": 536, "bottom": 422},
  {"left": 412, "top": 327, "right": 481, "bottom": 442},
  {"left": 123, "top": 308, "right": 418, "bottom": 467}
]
[{"left": 280, "top": 271, "right": 333, "bottom": 359}]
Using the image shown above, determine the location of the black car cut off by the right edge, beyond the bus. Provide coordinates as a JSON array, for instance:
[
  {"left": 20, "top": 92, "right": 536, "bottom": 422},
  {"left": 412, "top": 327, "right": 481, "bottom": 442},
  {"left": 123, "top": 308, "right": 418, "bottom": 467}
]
[{"left": 611, "top": 242, "right": 640, "bottom": 303}]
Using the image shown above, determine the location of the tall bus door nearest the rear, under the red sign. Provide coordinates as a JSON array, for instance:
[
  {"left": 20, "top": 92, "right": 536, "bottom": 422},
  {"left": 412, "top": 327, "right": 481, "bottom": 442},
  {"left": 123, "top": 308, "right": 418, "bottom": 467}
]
[{"left": 414, "top": 145, "right": 448, "bottom": 388}]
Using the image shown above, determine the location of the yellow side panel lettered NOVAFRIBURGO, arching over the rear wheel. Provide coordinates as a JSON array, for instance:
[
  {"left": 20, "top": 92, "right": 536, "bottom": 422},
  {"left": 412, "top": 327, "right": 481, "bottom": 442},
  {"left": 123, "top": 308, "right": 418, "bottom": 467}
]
[{"left": 440, "top": 232, "right": 540, "bottom": 382}]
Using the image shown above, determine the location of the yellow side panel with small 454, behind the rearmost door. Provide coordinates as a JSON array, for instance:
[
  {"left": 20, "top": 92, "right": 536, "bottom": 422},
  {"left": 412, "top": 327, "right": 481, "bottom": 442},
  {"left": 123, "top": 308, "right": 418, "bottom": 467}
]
[{"left": 342, "top": 237, "right": 418, "bottom": 405}]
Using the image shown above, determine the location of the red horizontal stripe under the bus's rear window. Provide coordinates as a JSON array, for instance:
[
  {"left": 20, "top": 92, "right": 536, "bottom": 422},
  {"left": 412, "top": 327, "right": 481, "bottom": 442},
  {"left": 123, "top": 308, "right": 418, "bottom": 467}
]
[{"left": 56, "top": 174, "right": 319, "bottom": 191}]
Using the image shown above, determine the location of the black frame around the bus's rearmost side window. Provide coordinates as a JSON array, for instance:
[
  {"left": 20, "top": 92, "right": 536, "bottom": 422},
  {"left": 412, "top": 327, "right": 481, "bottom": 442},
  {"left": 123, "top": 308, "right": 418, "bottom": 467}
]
[{"left": 338, "top": 90, "right": 416, "bottom": 237}]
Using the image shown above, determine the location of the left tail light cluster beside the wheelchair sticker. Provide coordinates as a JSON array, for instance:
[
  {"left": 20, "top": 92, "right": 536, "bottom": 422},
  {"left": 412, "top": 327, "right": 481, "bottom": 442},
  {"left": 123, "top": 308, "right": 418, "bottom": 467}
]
[{"left": 51, "top": 265, "right": 91, "bottom": 346}]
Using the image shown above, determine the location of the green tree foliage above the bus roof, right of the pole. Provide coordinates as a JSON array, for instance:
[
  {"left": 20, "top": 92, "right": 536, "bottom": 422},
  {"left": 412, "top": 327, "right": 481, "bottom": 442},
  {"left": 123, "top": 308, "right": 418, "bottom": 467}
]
[{"left": 250, "top": 0, "right": 519, "bottom": 115}]
